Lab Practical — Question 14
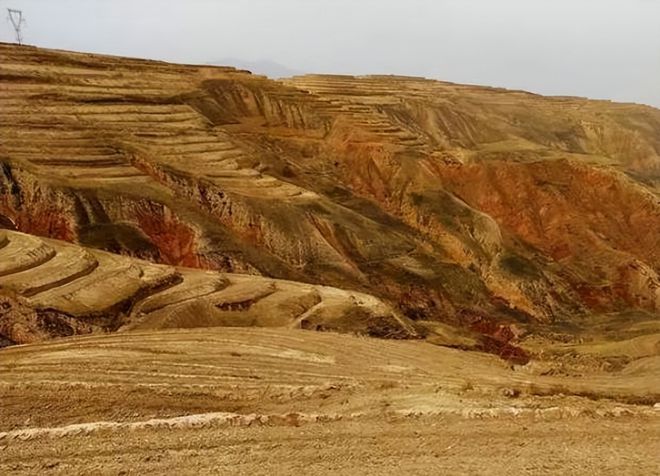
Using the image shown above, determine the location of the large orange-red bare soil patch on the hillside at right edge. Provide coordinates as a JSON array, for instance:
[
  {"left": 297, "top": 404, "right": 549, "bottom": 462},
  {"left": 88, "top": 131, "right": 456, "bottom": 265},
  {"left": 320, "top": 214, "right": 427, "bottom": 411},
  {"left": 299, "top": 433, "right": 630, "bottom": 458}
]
[{"left": 435, "top": 160, "right": 660, "bottom": 311}]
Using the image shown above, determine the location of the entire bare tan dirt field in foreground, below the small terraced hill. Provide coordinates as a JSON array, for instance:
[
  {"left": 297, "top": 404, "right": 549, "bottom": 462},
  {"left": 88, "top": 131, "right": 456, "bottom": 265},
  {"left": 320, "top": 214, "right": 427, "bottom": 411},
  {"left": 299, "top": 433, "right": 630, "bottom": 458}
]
[{"left": 0, "top": 328, "right": 660, "bottom": 475}]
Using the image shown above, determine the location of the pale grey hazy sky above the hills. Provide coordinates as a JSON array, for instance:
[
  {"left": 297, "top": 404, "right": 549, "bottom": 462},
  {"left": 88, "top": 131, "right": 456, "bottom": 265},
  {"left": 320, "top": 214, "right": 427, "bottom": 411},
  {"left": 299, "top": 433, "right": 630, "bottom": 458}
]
[{"left": 0, "top": 0, "right": 660, "bottom": 107}]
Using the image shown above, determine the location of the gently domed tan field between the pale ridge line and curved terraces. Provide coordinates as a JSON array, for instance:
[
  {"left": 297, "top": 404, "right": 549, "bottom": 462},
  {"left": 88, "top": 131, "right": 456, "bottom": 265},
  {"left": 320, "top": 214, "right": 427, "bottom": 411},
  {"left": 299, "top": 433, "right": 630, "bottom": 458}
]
[{"left": 0, "top": 328, "right": 660, "bottom": 436}]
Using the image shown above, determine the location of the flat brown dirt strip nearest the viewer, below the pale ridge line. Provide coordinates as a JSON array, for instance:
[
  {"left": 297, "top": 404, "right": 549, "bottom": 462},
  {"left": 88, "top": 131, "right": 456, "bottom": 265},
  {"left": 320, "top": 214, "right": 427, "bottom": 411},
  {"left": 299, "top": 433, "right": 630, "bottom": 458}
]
[{"left": 0, "top": 416, "right": 660, "bottom": 475}]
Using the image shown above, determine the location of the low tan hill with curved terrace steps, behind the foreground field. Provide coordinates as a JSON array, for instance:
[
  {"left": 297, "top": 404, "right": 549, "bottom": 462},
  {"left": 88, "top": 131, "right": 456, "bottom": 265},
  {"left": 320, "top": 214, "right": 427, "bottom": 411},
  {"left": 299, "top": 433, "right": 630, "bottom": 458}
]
[{"left": 0, "top": 230, "right": 415, "bottom": 344}]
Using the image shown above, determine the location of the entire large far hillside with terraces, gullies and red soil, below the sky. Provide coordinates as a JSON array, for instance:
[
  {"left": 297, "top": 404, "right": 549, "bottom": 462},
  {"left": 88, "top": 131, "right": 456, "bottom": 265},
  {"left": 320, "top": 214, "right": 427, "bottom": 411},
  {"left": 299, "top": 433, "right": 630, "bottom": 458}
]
[{"left": 0, "top": 45, "right": 660, "bottom": 332}]
